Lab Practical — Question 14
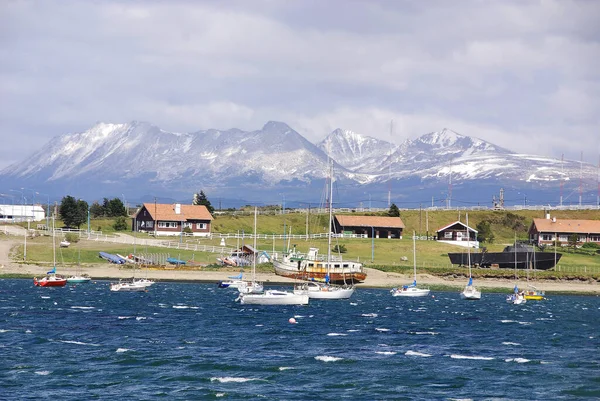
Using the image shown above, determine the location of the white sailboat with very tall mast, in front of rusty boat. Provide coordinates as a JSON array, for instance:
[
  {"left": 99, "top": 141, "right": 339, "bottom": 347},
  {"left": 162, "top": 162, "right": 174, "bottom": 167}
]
[{"left": 294, "top": 162, "right": 356, "bottom": 299}]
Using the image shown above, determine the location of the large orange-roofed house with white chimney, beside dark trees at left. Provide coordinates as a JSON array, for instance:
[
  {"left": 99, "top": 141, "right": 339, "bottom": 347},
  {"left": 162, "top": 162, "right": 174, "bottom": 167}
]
[{"left": 132, "top": 203, "right": 213, "bottom": 236}]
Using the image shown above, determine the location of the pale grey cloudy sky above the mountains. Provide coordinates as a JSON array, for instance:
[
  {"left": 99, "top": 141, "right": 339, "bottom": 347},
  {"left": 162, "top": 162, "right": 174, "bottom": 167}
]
[{"left": 0, "top": 0, "right": 600, "bottom": 169}]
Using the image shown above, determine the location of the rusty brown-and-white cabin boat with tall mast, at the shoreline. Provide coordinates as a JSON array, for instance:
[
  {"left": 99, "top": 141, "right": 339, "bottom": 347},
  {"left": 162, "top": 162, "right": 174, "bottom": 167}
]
[{"left": 272, "top": 162, "right": 367, "bottom": 285}]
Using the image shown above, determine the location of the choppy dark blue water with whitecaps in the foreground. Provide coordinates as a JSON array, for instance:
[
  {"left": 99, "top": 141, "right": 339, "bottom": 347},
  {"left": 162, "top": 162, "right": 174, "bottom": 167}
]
[{"left": 0, "top": 280, "right": 600, "bottom": 400}]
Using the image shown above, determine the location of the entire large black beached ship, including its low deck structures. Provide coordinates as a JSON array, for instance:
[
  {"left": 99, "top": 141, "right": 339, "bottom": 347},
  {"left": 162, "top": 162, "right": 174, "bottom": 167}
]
[{"left": 448, "top": 242, "right": 562, "bottom": 270}]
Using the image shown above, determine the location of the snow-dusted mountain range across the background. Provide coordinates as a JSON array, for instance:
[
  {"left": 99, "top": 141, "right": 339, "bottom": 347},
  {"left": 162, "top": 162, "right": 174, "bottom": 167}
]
[{"left": 0, "top": 121, "right": 598, "bottom": 207}]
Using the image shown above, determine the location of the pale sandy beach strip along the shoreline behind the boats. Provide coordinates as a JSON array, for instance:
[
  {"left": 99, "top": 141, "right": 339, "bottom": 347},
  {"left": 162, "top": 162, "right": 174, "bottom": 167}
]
[{"left": 0, "top": 240, "right": 600, "bottom": 295}]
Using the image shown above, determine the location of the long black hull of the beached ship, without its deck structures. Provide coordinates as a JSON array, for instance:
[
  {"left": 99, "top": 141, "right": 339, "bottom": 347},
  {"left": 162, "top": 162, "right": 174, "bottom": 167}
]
[{"left": 448, "top": 252, "right": 562, "bottom": 270}]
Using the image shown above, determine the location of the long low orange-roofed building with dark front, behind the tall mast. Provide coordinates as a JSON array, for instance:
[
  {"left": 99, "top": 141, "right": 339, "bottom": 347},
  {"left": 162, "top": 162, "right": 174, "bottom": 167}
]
[{"left": 333, "top": 215, "right": 404, "bottom": 239}]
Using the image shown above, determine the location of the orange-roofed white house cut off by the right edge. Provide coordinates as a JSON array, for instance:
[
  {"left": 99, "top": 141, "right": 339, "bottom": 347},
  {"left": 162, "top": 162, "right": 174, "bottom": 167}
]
[{"left": 529, "top": 213, "right": 600, "bottom": 246}]
